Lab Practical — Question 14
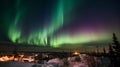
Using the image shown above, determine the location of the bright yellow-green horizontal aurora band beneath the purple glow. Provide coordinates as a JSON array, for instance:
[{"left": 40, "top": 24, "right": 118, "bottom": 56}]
[{"left": 51, "top": 32, "right": 110, "bottom": 47}]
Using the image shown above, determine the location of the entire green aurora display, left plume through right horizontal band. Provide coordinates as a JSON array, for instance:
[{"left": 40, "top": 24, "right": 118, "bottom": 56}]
[{"left": 8, "top": 0, "right": 108, "bottom": 48}]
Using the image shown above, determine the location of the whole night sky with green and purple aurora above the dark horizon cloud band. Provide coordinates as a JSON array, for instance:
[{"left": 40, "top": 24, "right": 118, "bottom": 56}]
[{"left": 0, "top": 0, "right": 120, "bottom": 48}]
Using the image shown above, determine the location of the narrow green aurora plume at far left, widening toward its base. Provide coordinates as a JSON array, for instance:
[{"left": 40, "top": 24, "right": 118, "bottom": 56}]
[{"left": 8, "top": 0, "right": 22, "bottom": 43}]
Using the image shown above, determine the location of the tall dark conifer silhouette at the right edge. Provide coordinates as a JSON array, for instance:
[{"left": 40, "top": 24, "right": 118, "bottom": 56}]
[{"left": 108, "top": 33, "right": 120, "bottom": 67}]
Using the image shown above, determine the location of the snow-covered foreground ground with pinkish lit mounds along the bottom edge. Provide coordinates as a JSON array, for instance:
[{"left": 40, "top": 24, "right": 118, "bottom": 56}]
[{"left": 0, "top": 55, "right": 110, "bottom": 67}]
